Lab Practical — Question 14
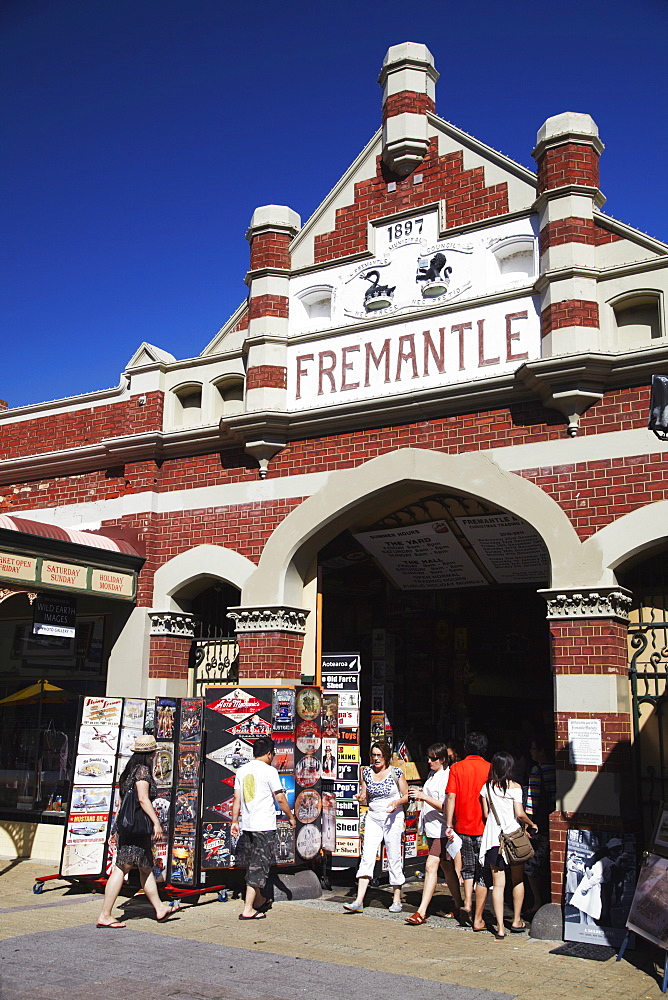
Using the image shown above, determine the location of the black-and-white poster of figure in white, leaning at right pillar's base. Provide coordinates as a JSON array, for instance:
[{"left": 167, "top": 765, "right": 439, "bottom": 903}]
[{"left": 564, "top": 830, "right": 636, "bottom": 948}]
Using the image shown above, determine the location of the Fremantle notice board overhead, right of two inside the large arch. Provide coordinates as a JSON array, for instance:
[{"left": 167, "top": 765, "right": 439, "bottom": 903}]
[{"left": 457, "top": 514, "right": 550, "bottom": 583}]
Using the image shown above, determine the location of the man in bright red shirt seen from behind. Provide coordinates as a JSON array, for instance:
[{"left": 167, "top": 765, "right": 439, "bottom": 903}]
[{"left": 445, "top": 733, "right": 489, "bottom": 931}]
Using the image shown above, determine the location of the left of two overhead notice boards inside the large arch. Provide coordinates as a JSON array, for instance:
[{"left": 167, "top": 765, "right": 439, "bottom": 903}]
[{"left": 355, "top": 521, "right": 487, "bottom": 590}]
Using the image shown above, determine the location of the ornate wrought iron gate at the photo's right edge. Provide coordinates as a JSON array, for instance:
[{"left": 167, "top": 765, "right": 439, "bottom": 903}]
[{"left": 629, "top": 620, "right": 668, "bottom": 841}]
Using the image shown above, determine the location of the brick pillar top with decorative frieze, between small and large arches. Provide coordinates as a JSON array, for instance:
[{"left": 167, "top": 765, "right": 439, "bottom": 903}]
[{"left": 228, "top": 606, "right": 308, "bottom": 685}]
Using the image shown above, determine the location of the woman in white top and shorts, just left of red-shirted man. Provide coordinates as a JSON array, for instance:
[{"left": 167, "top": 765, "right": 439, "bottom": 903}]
[{"left": 405, "top": 743, "right": 462, "bottom": 926}]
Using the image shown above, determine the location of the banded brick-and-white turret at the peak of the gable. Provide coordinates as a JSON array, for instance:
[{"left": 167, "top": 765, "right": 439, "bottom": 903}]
[{"left": 378, "top": 42, "right": 438, "bottom": 177}]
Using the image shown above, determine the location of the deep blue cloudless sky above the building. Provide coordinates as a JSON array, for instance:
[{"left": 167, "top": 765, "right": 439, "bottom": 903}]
[{"left": 0, "top": 0, "right": 668, "bottom": 406}]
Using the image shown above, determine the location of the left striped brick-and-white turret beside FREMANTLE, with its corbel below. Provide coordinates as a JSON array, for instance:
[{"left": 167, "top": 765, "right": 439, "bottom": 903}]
[{"left": 246, "top": 205, "right": 301, "bottom": 478}]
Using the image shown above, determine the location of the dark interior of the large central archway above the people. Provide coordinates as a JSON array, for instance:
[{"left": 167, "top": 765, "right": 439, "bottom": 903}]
[{"left": 319, "top": 493, "right": 554, "bottom": 772}]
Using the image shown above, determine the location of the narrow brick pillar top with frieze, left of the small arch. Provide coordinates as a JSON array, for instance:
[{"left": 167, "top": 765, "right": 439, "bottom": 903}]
[{"left": 148, "top": 611, "right": 197, "bottom": 697}]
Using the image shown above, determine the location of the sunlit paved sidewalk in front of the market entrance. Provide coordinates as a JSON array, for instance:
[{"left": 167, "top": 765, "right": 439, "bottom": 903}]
[{"left": 0, "top": 861, "right": 663, "bottom": 1000}]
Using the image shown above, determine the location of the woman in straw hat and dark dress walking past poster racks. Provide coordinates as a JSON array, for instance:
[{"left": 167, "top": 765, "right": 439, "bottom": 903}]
[{"left": 97, "top": 736, "right": 181, "bottom": 930}]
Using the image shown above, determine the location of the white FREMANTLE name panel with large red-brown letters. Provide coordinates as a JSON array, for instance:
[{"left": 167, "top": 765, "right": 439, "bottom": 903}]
[{"left": 288, "top": 297, "right": 540, "bottom": 410}]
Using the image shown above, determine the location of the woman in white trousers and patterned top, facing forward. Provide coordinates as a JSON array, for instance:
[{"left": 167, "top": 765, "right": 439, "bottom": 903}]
[{"left": 343, "top": 740, "right": 408, "bottom": 913}]
